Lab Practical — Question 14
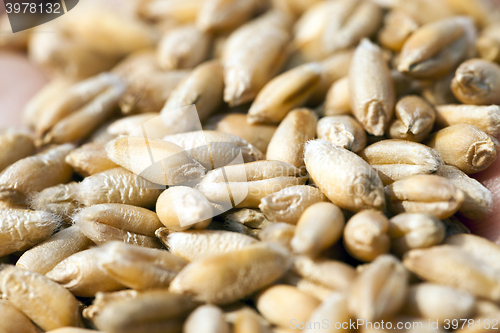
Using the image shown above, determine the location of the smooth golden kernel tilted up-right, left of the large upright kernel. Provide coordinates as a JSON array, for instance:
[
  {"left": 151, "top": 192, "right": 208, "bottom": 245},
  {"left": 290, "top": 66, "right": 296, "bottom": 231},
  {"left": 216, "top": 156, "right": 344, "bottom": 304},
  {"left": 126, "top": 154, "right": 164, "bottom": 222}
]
[{"left": 248, "top": 63, "right": 322, "bottom": 124}]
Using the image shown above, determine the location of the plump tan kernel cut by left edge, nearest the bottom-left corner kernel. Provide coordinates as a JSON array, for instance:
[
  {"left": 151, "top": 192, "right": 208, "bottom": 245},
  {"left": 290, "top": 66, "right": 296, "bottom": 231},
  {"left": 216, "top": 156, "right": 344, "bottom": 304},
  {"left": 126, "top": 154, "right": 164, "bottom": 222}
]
[{"left": 0, "top": 266, "right": 82, "bottom": 331}]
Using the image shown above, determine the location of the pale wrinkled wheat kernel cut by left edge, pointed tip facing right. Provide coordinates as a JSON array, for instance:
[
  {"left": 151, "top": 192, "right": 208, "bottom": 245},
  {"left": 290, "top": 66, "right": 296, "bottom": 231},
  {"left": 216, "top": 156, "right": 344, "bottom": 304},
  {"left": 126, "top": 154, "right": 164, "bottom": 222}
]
[{"left": 0, "top": 208, "right": 61, "bottom": 257}]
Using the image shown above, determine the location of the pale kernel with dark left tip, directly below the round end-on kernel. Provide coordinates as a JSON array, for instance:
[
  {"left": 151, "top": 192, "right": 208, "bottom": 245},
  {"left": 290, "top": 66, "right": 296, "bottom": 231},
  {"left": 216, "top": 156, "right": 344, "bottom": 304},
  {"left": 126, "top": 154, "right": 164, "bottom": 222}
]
[{"left": 156, "top": 228, "right": 257, "bottom": 262}]
